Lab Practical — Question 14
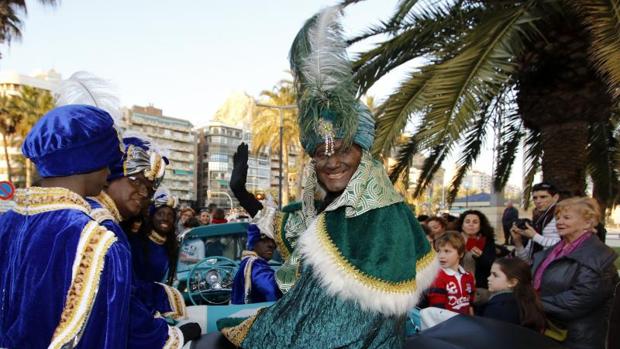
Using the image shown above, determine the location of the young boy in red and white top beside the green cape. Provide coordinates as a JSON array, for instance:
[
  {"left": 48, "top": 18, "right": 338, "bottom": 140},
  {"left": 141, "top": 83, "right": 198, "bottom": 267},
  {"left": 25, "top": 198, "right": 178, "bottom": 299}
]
[{"left": 427, "top": 232, "right": 476, "bottom": 315}]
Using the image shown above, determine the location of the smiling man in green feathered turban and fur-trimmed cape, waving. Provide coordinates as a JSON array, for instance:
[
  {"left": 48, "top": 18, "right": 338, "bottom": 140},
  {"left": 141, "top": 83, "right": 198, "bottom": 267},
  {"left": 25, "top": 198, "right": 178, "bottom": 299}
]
[{"left": 222, "top": 7, "right": 438, "bottom": 348}]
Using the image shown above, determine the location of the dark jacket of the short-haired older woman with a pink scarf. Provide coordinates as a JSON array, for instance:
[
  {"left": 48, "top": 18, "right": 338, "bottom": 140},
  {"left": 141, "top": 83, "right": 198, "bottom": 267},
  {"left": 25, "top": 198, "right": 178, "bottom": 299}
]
[{"left": 532, "top": 235, "right": 618, "bottom": 349}]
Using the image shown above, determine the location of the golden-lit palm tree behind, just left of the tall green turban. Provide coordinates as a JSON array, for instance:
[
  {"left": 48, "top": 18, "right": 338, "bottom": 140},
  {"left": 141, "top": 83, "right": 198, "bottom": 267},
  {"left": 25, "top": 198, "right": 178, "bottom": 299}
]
[{"left": 252, "top": 80, "right": 304, "bottom": 205}]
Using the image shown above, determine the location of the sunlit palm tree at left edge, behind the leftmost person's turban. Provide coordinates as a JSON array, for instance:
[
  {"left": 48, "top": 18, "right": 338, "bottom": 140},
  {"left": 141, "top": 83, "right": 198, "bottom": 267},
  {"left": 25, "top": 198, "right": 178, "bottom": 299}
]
[{"left": 0, "top": 86, "right": 54, "bottom": 186}]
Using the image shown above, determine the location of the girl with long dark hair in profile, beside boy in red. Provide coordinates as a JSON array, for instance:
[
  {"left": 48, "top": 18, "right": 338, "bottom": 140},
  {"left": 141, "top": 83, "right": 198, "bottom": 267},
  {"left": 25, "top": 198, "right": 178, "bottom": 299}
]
[{"left": 481, "top": 258, "right": 545, "bottom": 331}]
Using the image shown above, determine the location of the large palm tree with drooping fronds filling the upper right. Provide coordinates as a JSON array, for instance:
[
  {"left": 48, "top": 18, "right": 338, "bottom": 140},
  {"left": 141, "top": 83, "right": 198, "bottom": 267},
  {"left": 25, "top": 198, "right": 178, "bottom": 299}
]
[{"left": 345, "top": 0, "right": 620, "bottom": 209}]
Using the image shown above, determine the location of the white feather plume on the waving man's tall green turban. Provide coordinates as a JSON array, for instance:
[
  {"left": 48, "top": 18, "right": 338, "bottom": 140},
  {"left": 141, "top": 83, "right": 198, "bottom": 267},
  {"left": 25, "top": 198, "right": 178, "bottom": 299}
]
[{"left": 302, "top": 6, "right": 351, "bottom": 93}]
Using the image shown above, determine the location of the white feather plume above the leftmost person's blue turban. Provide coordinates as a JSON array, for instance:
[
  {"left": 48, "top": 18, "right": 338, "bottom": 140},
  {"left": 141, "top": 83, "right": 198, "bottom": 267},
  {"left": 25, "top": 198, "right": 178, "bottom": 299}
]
[{"left": 54, "top": 71, "right": 121, "bottom": 124}]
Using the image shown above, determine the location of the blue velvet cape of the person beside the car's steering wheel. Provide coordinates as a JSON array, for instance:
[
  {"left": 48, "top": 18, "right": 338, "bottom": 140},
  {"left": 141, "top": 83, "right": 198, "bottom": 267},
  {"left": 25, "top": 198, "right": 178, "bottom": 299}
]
[{"left": 230, "top": 254, "right": 282, "bottom": 304}]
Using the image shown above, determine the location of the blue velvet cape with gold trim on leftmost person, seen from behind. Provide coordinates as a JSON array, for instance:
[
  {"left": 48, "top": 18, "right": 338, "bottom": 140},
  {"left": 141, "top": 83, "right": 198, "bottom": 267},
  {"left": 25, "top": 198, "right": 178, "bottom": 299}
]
[{"left": 0, "top": 187, "right": 131, "bottom": 349}]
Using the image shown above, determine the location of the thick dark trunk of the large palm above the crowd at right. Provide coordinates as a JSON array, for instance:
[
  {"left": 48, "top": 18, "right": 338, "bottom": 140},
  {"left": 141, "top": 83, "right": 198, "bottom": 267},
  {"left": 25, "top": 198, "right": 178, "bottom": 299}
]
[{"left": 517, "top": 20, "right": 613, "bottom": 195}]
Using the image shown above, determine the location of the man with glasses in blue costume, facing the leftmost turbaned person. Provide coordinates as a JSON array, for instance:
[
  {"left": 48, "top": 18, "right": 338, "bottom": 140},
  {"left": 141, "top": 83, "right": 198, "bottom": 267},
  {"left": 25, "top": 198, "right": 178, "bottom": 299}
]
[{"left": 87, "top": 136, "right": 200, "bottom": 348}]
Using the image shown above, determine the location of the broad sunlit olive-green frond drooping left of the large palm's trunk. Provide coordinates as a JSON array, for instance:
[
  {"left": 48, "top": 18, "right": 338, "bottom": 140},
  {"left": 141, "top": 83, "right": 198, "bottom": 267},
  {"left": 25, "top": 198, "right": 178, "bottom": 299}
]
[{"left": 421, "top": 2, "right": 534, "bottom": 151}]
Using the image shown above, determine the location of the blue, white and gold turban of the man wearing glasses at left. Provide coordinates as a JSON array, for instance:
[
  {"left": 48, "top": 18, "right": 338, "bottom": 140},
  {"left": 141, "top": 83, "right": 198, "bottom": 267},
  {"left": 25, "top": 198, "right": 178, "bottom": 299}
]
[{"left": 108, "top": 136, "right": 169, "bottom": 187}]
